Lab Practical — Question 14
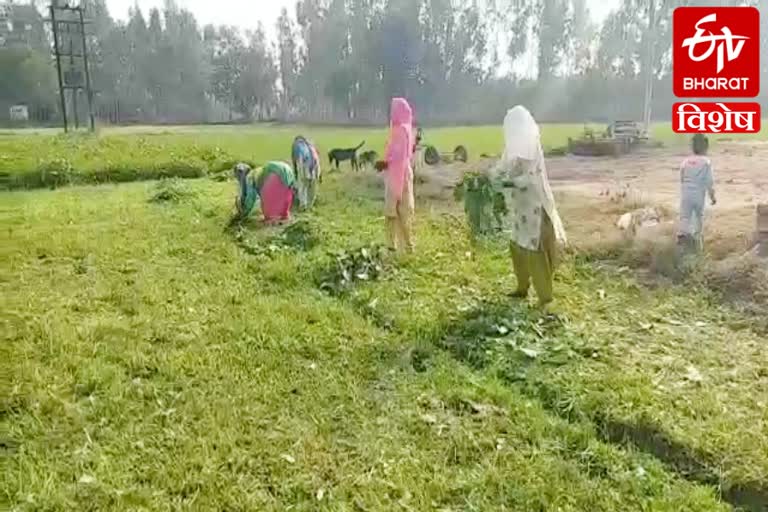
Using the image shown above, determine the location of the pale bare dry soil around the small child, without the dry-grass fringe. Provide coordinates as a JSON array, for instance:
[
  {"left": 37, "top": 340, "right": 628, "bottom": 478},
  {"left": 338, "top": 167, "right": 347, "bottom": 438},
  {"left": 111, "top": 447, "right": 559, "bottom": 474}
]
[{"left": 417, "top": 141, "right": 768, "bottom": 258}]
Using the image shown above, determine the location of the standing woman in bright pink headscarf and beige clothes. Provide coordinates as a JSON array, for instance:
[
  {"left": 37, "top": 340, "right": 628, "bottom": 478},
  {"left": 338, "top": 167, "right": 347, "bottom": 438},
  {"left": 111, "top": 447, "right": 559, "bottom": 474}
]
[{"left": 377, "top": 98, "right": 415, "bottom": 252}]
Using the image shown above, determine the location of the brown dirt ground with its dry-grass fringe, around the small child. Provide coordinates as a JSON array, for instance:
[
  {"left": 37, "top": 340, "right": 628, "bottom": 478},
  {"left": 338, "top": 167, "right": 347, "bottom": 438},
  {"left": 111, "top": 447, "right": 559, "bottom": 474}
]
[{"left": 416, "top": 141, "right": 768, "bottom": 315}]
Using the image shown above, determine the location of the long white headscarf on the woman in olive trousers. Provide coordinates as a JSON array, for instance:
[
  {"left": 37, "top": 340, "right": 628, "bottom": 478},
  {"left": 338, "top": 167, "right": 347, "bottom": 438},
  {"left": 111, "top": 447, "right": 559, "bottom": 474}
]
[{"left": 502, "top": 105, "right": 567, "bottom": 243}]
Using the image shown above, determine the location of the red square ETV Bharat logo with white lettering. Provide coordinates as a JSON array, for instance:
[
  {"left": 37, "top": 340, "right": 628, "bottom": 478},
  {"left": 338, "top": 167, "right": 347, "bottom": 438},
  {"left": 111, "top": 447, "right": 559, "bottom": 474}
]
[{"left": 672, "top": 7, "right": 760, "bottom": 98}]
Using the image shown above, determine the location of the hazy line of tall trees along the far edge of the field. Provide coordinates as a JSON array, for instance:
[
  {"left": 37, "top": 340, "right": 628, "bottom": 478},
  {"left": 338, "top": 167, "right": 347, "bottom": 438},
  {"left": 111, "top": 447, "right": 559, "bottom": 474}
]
[{"left": 0, "top": 0, "right": 768, "bottom": 124}]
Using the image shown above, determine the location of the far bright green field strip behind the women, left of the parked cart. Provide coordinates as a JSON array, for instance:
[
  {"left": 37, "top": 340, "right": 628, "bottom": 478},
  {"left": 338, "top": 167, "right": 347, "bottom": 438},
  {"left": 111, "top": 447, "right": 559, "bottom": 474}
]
[{"left": 0, "top": 125, "right": 581, "bottom": 185}]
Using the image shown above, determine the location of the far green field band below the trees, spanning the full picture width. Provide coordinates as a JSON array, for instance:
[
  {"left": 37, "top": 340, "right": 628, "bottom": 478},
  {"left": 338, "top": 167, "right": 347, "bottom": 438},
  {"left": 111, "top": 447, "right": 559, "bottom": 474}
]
[{"left": 0, "top": 123, "right": 768, "bottom": 188}]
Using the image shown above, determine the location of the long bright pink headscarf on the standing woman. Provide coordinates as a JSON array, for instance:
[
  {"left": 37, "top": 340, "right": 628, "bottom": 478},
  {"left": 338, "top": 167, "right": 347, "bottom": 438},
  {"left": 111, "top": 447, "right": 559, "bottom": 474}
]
[{"left": 386, "top": 98, "right": 416, "bottom": 200}]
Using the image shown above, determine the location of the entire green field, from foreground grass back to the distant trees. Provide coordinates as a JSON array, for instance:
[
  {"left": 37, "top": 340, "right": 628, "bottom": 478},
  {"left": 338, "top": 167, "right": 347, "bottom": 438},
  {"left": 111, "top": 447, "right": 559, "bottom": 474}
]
[{"left": 0, "top": 126, "right": 768, "bottom": 512}]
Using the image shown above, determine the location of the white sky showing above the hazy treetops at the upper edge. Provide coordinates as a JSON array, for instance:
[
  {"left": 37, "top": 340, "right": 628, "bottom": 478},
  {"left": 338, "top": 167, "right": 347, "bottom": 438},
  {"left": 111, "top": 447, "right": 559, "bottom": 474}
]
[{"left": 107, "top": 0, "right": 619, "bottom": 41}]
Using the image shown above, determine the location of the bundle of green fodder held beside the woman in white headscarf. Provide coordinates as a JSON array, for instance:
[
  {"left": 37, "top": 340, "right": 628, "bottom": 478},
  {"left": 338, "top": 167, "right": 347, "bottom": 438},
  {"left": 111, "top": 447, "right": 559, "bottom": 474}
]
[{"left": 454, "top": 172, "right": 507, "bottom": 241}]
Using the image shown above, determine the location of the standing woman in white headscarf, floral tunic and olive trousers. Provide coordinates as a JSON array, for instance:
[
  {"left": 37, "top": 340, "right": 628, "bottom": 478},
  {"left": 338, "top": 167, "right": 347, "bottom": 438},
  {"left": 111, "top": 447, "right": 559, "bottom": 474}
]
[{"left": 488, "top": 105, "right": 567, "bottom": 307}]
